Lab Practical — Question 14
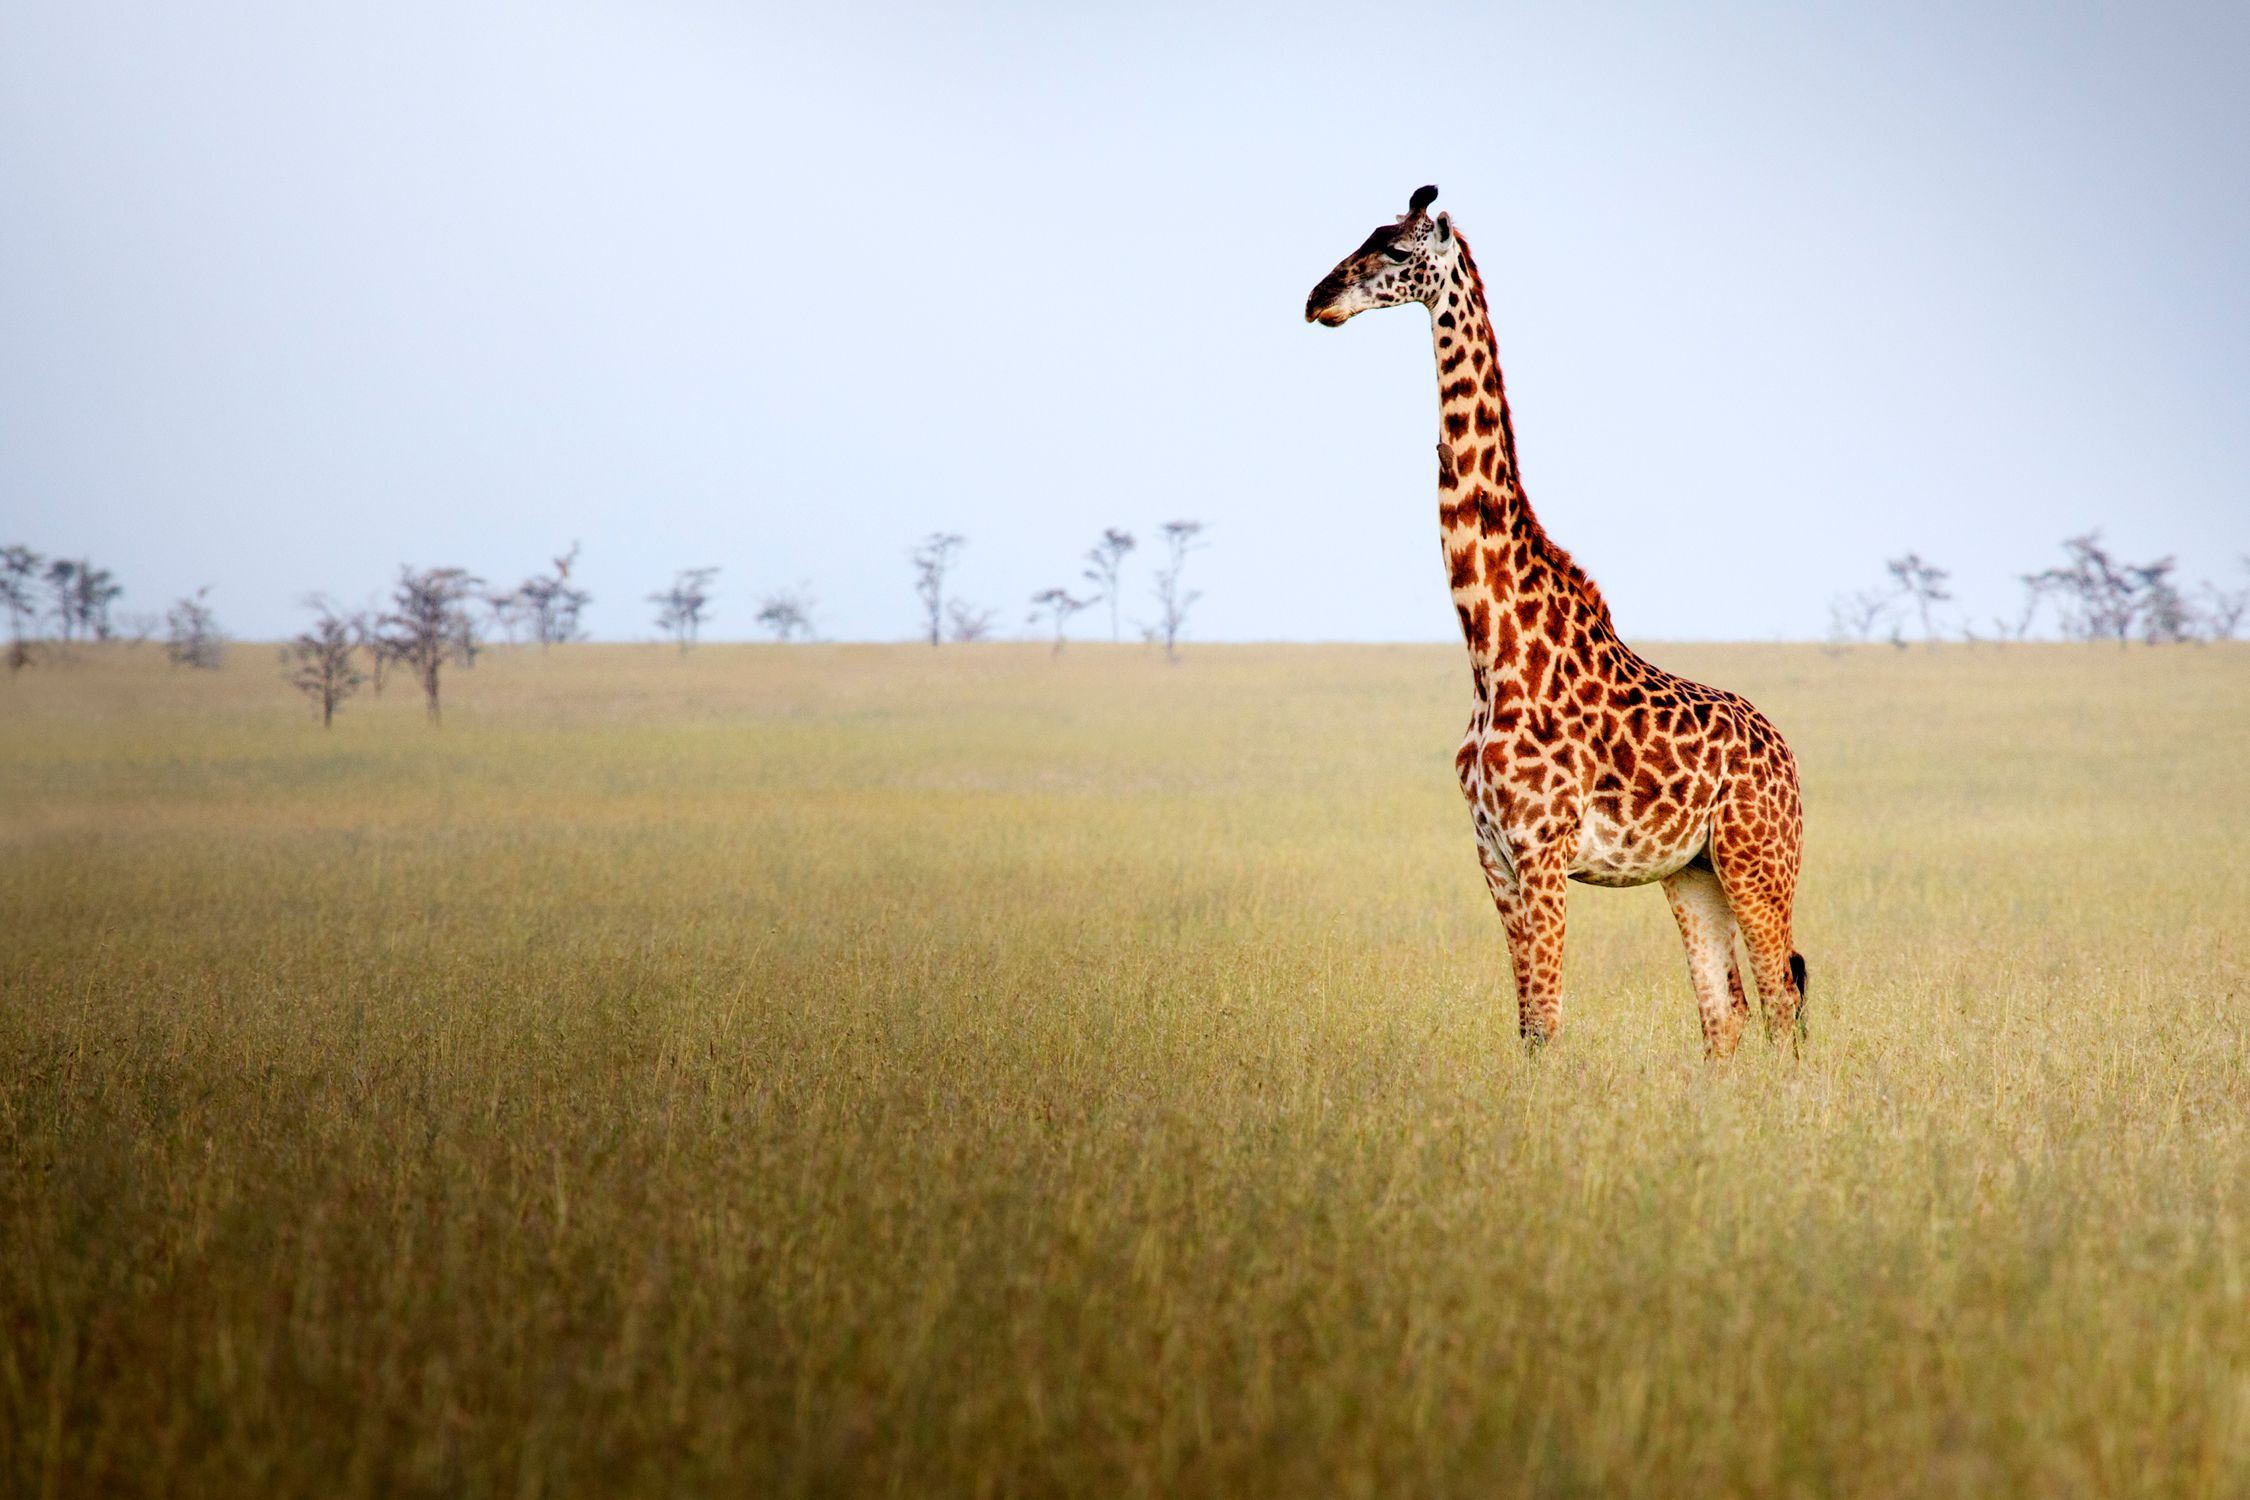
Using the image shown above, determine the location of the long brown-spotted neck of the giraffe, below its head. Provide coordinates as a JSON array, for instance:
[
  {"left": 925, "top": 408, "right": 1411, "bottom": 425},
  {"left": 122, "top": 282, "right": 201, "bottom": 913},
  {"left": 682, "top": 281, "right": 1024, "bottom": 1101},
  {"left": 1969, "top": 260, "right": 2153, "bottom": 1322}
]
[{"left": 1431, "top": 232, "right": 1616, "bottom": 697}]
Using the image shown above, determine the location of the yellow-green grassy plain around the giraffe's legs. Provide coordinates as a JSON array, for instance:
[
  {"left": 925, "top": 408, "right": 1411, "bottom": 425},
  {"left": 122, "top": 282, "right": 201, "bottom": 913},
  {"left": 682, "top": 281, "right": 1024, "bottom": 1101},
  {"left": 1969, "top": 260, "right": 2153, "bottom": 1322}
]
[{"left": 0, "top": 648, "right": 2250, "bottom": 1498}]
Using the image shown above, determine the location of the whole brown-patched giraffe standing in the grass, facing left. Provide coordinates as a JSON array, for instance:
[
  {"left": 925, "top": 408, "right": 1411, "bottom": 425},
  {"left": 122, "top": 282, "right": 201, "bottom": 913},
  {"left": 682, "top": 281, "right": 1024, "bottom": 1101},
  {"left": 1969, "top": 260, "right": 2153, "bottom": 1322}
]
[{"left": 1305, "top": 187, "right": 1805, "bottom": 1059}]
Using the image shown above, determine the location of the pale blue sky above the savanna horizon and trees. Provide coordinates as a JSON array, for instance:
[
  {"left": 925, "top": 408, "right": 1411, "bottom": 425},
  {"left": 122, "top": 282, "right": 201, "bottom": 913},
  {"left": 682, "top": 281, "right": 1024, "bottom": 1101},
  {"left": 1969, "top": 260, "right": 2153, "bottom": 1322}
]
[{"left": 0, "top": 0, "right": 2250, "bottom": 639}]
